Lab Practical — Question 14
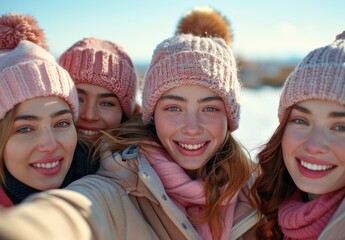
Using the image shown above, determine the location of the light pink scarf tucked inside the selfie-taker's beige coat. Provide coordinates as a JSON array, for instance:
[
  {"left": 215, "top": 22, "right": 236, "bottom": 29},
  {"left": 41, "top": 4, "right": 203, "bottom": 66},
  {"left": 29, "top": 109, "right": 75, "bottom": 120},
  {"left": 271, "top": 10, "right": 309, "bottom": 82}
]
[{"left": 147, "top": 150, "right": 237, "bottom": 239}]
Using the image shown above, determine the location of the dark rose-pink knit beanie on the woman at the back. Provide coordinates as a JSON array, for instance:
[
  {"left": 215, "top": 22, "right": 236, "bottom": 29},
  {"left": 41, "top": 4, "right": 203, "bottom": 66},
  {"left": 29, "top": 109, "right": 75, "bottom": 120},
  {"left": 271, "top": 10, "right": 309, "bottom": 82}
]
[{"left": 60, "top": 38, "right": 137, "bottom": 117}]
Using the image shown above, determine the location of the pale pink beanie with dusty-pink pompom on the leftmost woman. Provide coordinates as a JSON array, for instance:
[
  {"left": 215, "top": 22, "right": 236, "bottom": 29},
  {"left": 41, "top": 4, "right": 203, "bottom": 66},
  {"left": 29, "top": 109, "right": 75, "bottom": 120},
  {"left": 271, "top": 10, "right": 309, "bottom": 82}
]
[{"left": 0, "top": 14, "right": 78, "bottom": 120}]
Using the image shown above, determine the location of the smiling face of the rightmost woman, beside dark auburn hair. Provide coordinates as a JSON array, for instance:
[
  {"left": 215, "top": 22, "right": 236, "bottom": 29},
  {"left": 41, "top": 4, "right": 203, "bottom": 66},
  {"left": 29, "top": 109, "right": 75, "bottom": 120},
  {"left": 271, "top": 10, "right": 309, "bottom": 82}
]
[{"left": 282, "top": 100, "right": 345, "bottom": 194}]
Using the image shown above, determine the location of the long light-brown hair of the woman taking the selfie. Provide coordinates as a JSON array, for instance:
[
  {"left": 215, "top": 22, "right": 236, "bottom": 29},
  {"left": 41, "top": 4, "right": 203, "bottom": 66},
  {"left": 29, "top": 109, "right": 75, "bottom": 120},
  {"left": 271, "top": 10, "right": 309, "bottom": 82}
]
[{"left": 94, "top": 114, "right": 252, "bottom": 239}]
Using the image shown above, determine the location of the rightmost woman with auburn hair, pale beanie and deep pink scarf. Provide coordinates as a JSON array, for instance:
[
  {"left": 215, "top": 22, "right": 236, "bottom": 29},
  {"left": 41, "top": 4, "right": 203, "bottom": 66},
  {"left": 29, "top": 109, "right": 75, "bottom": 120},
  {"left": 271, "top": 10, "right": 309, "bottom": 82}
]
[{"left": 252, "top": 31, "right": 345, "bottom": 240}]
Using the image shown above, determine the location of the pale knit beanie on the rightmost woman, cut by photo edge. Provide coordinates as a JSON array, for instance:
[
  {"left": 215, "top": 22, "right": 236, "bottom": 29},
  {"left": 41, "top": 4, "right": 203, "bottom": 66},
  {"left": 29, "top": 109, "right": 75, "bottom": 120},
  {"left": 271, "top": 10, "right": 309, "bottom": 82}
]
[{"left": 278, "top": 31, "right": 345, "bottom": 121}]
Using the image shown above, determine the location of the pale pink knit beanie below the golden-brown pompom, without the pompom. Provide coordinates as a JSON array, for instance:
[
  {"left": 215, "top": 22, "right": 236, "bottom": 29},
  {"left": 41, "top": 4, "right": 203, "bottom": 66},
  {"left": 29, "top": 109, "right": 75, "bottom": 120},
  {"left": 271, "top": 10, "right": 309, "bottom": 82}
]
[{"left": 142, "top": 34, "right": 240, "bottom": 131}]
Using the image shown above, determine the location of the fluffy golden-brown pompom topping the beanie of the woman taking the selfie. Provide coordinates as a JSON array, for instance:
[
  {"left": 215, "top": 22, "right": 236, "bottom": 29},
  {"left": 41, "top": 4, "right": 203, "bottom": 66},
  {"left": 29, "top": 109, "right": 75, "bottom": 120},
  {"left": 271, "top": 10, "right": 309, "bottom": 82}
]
[{"left": 176, "top": 6, "right": 233, "bottom": 47}]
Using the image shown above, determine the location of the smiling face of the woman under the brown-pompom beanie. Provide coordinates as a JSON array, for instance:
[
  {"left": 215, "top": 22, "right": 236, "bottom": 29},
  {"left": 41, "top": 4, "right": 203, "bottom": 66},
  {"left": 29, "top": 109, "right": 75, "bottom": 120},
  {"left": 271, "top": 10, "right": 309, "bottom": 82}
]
[{"left": 154, "top": 85, "right": 228, "bottom": 174}]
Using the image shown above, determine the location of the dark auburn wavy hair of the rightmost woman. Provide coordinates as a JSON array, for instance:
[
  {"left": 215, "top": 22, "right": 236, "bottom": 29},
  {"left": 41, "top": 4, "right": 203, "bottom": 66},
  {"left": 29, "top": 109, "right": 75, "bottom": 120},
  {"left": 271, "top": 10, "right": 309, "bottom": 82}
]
[{"left": 250, "top": 108, "right": 297, "bottom": 240}]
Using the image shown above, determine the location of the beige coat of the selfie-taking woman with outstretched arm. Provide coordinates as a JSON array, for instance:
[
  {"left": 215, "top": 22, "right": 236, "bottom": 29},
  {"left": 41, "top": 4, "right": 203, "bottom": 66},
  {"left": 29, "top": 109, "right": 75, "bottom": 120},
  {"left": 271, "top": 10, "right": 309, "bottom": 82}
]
[{"left": 0, "top": 146, "right": 255, "bottom": 240}]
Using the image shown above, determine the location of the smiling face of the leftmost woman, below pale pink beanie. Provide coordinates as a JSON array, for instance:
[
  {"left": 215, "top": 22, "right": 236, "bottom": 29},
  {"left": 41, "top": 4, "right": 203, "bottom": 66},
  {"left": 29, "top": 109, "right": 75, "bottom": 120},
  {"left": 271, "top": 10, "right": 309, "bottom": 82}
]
[{"left": 4, "top": 97, "right": 77, "bottom": 190}]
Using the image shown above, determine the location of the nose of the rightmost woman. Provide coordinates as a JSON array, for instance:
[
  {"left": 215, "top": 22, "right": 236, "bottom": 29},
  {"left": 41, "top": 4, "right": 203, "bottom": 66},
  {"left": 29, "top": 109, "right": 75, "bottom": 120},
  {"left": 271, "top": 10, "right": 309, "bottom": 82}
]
[{"left": 304, "top": 127, "right": 328, "bottom": 154}]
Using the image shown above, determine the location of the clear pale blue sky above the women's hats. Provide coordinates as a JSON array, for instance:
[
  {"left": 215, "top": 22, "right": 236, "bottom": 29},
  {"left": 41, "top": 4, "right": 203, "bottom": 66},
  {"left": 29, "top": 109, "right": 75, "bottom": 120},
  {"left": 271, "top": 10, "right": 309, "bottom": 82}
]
[{"left": 0, "top": 0, "right": 345, "bottom": 63}]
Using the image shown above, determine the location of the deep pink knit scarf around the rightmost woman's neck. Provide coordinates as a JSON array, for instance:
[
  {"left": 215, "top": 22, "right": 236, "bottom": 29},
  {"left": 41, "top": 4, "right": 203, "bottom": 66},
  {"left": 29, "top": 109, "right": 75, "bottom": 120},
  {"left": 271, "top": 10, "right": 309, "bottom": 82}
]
[{"left": 278, "top": 188, "right": 345, "bottom": 240}]
